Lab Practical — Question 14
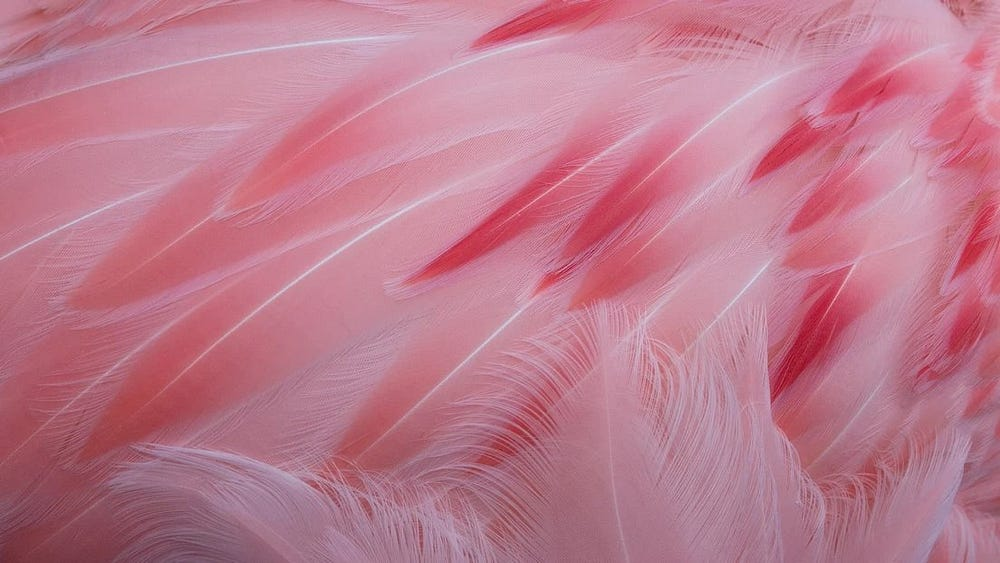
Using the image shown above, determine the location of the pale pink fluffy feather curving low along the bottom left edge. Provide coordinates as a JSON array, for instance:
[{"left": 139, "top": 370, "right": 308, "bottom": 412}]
[{"left": 108, "top": 447, "right": 489, "bottom": 561}]
